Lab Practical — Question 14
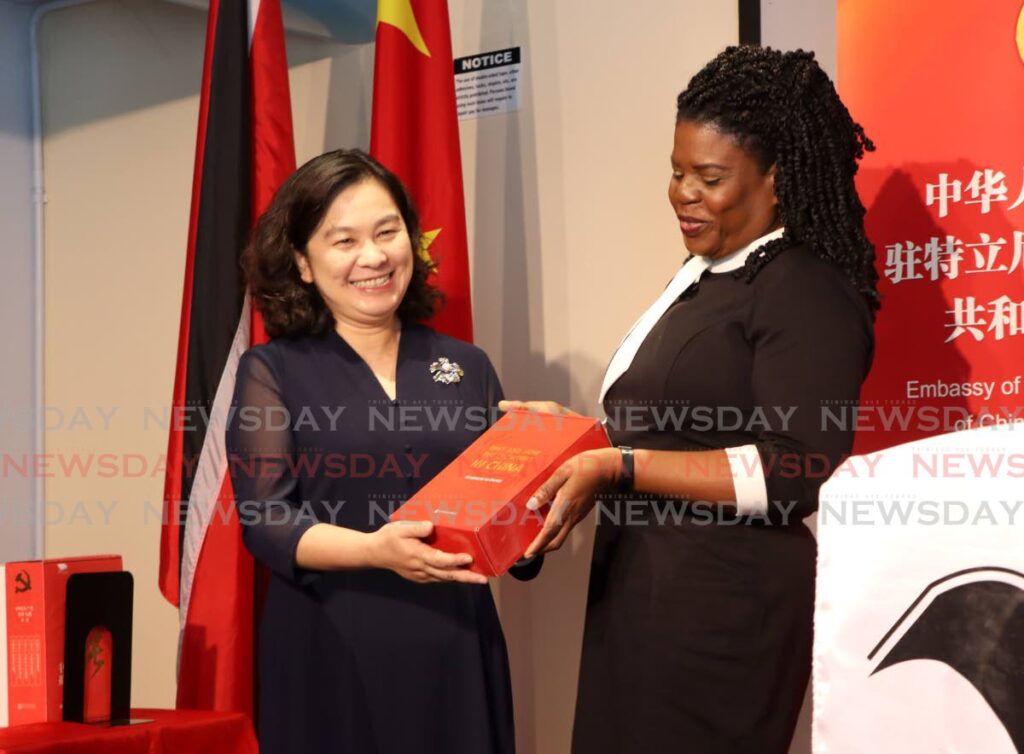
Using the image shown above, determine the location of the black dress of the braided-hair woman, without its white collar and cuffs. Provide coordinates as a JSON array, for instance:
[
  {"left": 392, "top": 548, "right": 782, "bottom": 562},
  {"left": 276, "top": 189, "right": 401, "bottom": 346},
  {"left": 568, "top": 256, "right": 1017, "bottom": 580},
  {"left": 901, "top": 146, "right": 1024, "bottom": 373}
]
[{"left": 572, "top": 248, "right": 873, "bottom": 754}]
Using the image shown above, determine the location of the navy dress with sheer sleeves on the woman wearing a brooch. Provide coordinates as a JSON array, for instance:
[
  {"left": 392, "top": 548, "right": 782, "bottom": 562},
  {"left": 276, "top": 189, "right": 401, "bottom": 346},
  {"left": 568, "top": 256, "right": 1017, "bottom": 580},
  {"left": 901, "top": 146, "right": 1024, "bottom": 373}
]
[{"left": 227, "top": 325, "right": 528, "bottom": 754}]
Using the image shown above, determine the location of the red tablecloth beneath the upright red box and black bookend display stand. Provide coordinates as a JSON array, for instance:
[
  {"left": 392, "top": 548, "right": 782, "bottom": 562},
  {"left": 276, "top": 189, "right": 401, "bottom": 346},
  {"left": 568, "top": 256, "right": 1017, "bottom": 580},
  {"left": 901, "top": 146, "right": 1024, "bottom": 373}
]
[{"left": 0, "top": 710, "right": 259, "bottom": 754}]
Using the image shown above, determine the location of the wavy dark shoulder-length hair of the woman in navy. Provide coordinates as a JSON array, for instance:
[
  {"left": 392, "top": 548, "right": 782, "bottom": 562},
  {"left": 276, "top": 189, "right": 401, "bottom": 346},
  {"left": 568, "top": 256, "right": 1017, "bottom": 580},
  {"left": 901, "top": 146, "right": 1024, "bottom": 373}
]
[{"left": 242, "top": 150, "right": 443, "bottom": 337}]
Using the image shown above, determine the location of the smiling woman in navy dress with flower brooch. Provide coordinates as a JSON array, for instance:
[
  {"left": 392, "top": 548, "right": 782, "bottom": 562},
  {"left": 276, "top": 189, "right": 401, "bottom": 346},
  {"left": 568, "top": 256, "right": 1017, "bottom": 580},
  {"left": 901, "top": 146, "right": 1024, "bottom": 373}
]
[{"left": 227, "top": 150, "right": 536, "bottom": 754}]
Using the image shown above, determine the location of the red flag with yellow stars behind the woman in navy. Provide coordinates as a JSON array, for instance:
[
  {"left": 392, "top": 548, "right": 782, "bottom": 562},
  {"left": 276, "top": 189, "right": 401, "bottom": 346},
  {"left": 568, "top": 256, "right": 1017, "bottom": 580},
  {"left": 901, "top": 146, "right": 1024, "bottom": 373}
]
[{"left": 370, "top": 0, "right": 473, "bottom": 340}]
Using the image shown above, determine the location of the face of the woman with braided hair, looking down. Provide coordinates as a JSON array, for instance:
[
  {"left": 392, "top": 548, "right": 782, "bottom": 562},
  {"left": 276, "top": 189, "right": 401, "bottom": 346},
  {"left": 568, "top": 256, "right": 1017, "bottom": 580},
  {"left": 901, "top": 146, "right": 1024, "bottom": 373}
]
[{"left": 669, "top": 121, "right": 779, "bottom": 259}]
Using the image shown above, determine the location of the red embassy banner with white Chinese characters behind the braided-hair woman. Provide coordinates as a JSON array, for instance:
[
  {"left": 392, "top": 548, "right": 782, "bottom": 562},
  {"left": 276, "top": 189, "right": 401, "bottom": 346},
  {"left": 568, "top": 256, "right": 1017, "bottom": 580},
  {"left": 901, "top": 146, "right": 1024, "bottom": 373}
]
[{"left": 839, "top": 0, "right": 1024, "bottom": 453}]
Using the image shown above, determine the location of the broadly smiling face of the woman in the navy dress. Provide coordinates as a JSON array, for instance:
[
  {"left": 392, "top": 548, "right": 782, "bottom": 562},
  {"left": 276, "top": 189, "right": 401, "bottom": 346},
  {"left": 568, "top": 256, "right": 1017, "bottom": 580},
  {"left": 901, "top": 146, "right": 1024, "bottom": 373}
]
[{"left": 295, "top": 178, "right": 413, "bottom": 327}]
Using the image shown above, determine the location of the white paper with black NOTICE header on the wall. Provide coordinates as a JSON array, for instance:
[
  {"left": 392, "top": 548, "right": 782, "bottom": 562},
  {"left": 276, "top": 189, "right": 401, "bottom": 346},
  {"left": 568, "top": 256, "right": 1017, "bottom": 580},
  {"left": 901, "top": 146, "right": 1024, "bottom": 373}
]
[{"left": 455, "top": 47, "right": 522, "bottom": 121}]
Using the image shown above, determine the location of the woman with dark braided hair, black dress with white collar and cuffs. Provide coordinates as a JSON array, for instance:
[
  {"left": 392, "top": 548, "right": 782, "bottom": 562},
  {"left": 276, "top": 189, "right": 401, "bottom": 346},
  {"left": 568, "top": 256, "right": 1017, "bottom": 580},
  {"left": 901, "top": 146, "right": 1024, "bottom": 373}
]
[{"left": 509, "top": 47, "right": 878, "bottom": 754}]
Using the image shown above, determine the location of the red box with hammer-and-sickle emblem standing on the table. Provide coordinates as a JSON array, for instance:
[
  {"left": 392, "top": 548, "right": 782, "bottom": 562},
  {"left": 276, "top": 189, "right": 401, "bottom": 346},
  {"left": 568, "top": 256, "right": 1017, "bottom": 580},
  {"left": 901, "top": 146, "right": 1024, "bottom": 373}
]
[{"left": 0, "top": 555, "right": 121, "bottom": 726}]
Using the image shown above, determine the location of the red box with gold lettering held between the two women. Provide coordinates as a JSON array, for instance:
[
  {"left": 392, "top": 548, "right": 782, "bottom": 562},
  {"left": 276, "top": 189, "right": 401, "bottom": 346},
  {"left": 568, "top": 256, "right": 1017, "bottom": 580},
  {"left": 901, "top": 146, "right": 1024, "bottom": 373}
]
[{"left": 391, "top": 411, "right": 609, "bottom": 576}]
